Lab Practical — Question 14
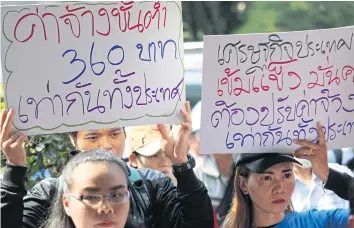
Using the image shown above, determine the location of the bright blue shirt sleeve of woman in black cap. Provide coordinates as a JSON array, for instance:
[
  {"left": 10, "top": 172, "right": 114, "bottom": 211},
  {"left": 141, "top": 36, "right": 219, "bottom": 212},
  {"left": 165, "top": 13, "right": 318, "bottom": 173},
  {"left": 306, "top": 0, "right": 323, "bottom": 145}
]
[{"left": 308, "top": 209, "right": 349, "bottom": 228}]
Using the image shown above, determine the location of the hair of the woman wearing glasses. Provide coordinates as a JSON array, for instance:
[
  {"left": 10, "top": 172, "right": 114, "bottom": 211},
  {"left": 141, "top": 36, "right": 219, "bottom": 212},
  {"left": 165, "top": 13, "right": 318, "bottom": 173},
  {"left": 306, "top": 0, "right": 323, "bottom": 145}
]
[{"left": 42, "top": 149, "right": 128, "bottom": 228}]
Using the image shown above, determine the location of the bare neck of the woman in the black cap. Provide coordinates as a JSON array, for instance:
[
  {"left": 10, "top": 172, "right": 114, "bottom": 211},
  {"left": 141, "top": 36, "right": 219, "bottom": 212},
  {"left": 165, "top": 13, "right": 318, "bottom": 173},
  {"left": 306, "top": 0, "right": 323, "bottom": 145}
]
[{"left": 253, "top": 205, "right": 285, "bottom": 227}]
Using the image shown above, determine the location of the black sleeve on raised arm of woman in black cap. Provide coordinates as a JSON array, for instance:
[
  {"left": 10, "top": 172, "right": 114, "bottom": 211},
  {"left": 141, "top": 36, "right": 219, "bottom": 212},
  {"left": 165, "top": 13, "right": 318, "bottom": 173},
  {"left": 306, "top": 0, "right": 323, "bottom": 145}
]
[{"left": 324, "top": 168, "right": 354, "bottom": 200}]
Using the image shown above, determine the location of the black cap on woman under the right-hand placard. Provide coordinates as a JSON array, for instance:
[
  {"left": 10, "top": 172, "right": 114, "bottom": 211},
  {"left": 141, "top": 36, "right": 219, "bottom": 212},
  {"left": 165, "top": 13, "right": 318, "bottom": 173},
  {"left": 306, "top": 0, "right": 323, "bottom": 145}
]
[{"left": 236, "top": 153, "right": 301, "bottom": 173}]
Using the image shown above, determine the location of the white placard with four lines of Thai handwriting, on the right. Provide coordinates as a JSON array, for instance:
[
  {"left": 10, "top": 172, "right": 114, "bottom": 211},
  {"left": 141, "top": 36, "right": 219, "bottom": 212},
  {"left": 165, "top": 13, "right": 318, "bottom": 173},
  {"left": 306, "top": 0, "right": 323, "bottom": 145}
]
[{"left": 201, "top": 27, "right": 354, "bottom": 154}]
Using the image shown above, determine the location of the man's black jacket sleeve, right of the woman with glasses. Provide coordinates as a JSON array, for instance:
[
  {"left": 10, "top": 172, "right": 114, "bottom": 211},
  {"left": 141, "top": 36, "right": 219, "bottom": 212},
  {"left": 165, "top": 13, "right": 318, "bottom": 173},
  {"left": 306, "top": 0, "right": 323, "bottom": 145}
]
[{"left": 154, "top": 170, "right": 214, "bottom": 228}]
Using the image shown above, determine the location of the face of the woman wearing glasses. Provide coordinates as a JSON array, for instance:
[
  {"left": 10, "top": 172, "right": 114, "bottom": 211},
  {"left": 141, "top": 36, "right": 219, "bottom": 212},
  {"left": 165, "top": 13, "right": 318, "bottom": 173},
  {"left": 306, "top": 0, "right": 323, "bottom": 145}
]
[{"left": 63, "top": 162, "right": 129, "bottom": 228}]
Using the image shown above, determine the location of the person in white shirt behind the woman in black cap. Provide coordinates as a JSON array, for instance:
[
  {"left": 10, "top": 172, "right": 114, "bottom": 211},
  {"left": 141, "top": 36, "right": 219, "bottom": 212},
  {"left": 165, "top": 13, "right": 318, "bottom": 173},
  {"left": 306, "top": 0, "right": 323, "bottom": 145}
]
[{"left": 292, "top": 159, "right": 354, "bottom": 211}]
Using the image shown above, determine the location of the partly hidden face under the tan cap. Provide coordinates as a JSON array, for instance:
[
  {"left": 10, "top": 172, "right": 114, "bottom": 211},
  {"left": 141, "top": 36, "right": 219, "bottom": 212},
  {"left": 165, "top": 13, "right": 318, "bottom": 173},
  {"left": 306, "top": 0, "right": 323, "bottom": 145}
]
[{"left": 132, "top": 150, "right": 173, "bottom": 176}]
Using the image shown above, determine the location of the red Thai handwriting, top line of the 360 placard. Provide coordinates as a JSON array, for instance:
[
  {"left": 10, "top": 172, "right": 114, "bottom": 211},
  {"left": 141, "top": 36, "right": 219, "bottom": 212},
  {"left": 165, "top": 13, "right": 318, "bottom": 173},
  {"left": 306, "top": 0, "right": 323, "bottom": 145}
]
[{"left": 13, "top": 1, "right": 167, "bottom": 43}]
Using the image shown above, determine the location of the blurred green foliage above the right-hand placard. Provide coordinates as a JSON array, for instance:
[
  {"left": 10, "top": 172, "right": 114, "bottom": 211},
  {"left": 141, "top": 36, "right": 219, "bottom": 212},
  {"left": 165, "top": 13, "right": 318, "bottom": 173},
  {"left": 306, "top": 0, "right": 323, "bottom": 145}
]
[{"left": 233, "top": 1, "right": 354, "bottom": 33}]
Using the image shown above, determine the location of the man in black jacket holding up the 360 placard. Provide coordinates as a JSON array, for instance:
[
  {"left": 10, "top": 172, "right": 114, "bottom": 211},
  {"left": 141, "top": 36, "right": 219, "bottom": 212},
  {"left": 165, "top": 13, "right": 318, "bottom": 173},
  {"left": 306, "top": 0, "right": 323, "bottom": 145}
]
[{"left": 0, "top": 102, "right": 214, "bottom": 228}]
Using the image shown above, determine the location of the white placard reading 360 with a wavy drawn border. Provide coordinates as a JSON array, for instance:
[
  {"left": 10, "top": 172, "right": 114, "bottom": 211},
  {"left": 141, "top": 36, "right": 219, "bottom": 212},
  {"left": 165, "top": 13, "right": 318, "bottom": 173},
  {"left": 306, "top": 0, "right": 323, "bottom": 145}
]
[{"left": 1, "top": 2, "right": 185, "bottom": 135}]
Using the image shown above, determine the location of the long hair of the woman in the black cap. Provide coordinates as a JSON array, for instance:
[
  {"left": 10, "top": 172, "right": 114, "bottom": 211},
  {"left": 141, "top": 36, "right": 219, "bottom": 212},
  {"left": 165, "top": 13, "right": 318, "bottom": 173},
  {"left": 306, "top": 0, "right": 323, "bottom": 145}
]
[{"left": 223, "top": 165, "right": 293, "bottom": 228}]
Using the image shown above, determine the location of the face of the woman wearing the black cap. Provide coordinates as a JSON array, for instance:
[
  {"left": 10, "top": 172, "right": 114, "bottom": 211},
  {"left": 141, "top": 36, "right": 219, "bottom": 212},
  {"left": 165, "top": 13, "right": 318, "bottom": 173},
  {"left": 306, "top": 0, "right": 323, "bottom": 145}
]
[{"left": 240, "top": 163, "right": 295, "bottom": 214}]
